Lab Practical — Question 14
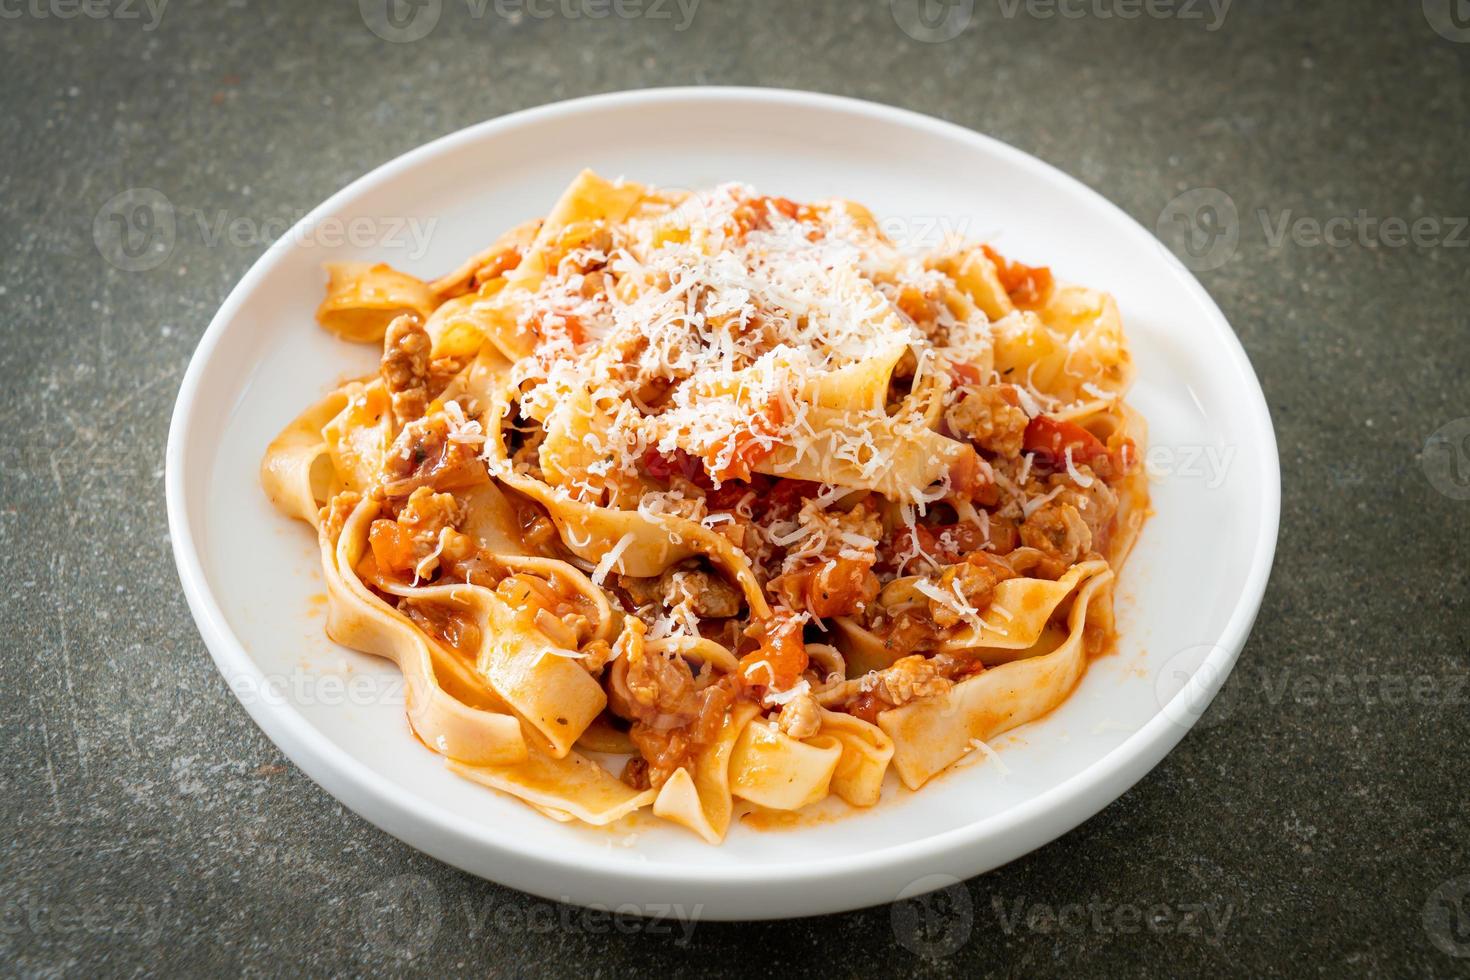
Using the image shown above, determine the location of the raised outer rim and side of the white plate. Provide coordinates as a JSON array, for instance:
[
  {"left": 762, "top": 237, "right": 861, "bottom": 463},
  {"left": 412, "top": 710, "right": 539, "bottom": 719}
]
[{"left": 165, "top": 87, "right": 1280, "bottom": 920}]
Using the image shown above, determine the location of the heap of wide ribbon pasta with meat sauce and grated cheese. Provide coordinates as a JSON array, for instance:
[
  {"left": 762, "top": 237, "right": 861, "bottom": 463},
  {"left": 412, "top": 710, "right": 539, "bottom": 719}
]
[{"left": 262, "top": 172, "right": 1148, "bottom": 843}]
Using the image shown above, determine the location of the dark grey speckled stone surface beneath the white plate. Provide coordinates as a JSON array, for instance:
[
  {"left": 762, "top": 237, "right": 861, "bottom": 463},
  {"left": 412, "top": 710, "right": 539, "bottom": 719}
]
[{"left": 0, "top": 0, "right": 1470, "bottom": 976}]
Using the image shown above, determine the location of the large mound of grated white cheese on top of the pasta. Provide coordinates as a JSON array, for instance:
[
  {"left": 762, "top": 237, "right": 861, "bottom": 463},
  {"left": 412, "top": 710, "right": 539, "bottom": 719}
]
[{"left": 512, "top": 184, "right": 946, "bottom": 498}]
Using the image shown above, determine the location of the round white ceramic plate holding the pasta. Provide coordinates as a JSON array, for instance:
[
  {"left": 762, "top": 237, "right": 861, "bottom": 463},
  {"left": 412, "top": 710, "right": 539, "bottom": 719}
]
[{"left": 168, "top": 88, "right": 1280, "bottom": 918}]
